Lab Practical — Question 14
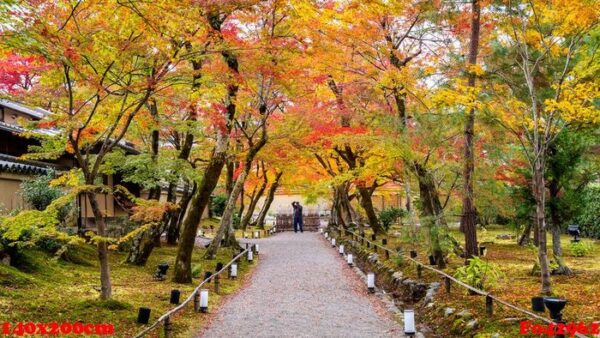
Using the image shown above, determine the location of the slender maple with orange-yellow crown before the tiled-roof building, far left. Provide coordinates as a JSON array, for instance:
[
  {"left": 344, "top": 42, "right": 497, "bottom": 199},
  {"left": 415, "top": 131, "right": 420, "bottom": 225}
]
[{"left": 3, "top": 1, "right": 177, "bottom": 299}]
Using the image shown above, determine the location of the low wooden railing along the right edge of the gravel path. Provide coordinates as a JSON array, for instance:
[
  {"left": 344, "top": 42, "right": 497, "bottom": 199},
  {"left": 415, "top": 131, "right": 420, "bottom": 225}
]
[{"left": 336, "top": 229, "right": 588, "bottom": 338}]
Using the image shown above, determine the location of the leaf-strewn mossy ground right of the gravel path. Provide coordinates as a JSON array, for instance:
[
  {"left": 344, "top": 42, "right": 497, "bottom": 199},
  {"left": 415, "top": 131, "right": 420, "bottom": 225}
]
[{"left": 358, "top": 227, "right": 600, "bottom": 337}]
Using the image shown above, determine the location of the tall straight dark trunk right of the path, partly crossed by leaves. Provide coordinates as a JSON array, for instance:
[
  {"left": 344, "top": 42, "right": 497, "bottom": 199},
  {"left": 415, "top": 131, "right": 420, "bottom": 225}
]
[{"left": 460, "top": 0, "right": 481, "bottom": 263}]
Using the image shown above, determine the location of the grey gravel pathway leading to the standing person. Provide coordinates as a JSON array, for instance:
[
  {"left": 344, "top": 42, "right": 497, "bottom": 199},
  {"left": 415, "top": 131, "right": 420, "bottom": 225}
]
[{"left": 199, "top": 232, "right": 404, "bottom": 337}]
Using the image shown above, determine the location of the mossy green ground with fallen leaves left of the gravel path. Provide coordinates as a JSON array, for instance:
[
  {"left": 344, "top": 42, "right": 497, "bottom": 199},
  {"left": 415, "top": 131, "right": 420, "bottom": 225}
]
[{"left": 0, "top": 242, "right": 251, "bottom": 337}]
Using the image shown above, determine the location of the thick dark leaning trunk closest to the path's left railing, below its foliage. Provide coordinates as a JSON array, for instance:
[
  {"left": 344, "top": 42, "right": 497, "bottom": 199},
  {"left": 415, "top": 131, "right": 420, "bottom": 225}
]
[{"left": 173, "top": 134, "right": 229, "bottom": 283}]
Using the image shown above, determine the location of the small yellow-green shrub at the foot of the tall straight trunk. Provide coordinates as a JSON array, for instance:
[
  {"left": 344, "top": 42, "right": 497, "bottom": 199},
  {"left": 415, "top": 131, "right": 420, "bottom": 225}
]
[{"left": 454, "top": 257, "right": 504, "bottom": 290}]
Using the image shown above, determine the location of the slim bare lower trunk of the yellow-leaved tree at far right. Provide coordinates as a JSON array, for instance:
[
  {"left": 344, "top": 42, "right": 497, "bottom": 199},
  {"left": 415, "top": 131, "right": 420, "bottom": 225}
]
[{"left": 532, "top": 160, "right": 552, "bottom": 295}]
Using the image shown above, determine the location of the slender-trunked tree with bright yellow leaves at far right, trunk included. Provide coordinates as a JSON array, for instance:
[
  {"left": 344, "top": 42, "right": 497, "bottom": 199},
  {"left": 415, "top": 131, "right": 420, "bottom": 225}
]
[{"left": 494, "top": 1, "right": 600, "bottom": 294}]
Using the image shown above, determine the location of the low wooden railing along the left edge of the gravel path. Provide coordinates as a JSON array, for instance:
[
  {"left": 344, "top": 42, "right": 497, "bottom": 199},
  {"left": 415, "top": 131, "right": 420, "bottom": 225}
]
[{"left": 134, "top": 244, "right": 255, "bottom": 338}]
